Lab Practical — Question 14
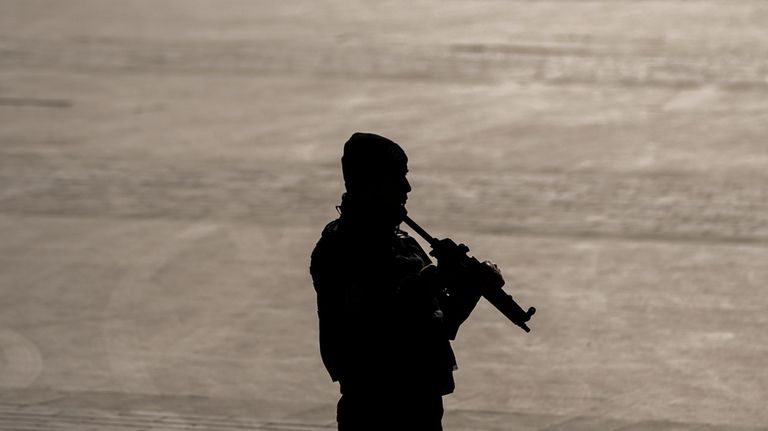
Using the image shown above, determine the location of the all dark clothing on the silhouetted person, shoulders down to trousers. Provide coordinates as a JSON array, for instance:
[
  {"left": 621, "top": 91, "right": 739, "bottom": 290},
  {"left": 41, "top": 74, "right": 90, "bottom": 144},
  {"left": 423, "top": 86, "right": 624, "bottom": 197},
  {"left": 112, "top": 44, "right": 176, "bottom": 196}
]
[{"left": 310, "top": 217, "right": 479, "bottom": 430}]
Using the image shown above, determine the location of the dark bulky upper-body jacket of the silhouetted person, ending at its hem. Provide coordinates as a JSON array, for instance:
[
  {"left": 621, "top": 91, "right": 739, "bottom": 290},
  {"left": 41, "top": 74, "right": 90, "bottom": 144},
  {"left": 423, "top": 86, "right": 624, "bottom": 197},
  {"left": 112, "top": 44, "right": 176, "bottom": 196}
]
[{"left": 311, "top": 220, "right": 456, "bottom": 395}]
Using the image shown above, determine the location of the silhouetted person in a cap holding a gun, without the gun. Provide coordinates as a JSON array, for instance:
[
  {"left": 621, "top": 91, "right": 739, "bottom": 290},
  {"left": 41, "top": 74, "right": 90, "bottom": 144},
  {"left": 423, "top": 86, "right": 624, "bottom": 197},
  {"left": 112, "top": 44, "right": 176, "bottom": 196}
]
[{"left": 310, "top": 133, "right": 503, "bottom": 431}]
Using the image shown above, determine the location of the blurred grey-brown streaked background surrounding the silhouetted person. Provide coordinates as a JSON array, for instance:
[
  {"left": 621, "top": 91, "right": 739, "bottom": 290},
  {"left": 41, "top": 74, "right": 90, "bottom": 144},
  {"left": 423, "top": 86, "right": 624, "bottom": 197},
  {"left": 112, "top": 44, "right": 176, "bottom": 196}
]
[{"left": 0, "top": 0, "right": 768, "bottom": 431}]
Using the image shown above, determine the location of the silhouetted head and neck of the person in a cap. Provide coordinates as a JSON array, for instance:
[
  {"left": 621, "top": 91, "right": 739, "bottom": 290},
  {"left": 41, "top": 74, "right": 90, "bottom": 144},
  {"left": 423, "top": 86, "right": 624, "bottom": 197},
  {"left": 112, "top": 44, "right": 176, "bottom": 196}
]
[{"left": 341, "top": 132, "right": 411, "bottom": 227}]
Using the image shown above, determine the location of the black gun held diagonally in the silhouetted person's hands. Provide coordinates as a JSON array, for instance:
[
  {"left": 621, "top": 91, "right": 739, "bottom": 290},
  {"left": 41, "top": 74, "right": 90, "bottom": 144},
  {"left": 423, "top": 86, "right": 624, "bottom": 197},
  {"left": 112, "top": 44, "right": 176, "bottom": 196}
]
[{"left": 403, "top": 216, "right": 536, "bottom": 332}]
